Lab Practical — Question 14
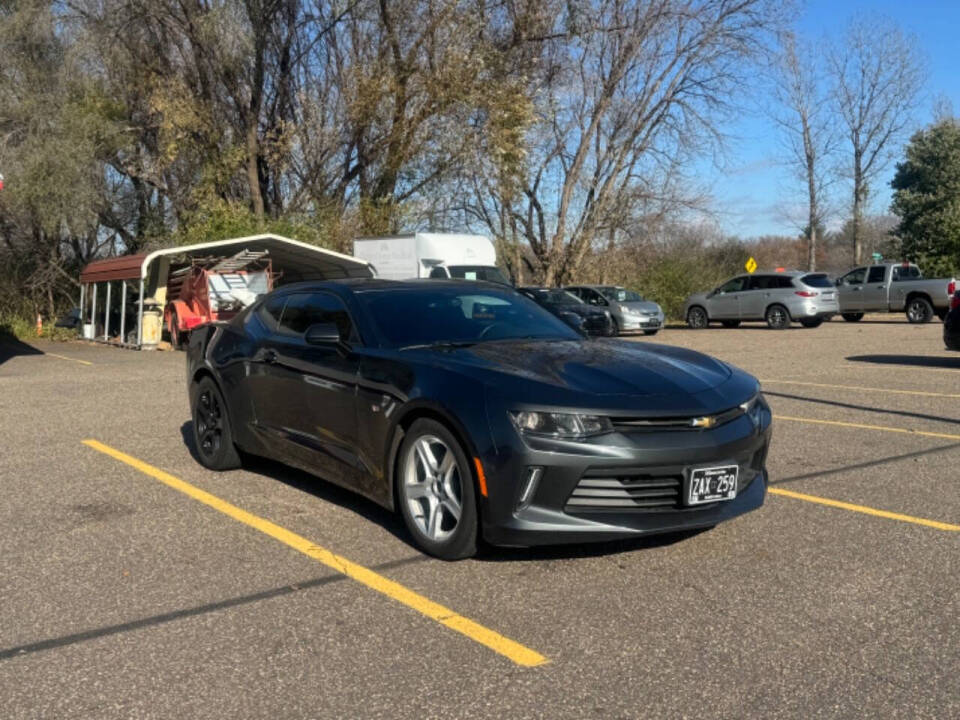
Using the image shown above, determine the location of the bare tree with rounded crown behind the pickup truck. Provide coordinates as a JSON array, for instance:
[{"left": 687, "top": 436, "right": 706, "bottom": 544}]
[{"left": 828, "top": 15, "right": 925, "bottom": 263}]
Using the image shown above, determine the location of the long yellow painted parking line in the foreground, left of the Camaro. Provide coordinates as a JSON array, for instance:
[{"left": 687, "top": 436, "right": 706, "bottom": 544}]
[{"left": 83, "top": 440, "right": 549, "bottom": 667}]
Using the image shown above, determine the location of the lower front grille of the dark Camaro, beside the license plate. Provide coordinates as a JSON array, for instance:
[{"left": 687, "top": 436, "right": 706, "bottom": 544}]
[{"left": 566, "top": 468, "right": 683, "bottom": 512}]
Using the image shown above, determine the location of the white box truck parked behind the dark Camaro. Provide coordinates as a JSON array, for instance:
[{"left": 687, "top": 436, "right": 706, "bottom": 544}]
[{"left": 353, "top": 233, "right": 509, "bottom": 284}]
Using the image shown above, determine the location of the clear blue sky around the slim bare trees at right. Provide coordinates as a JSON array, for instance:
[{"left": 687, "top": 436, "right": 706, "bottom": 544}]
[{"left": 701, "top": 0, "right": 960, "bottom": 242}]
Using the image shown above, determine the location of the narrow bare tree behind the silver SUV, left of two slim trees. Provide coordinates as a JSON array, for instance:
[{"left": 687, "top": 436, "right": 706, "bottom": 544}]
[{"left": 771, "top": 32, "right": 838, "bottom": 271}]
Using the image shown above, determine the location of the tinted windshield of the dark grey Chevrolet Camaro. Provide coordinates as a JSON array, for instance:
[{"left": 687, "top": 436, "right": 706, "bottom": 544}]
[{"left": 357, "top": 287, "right": 581, "bottom": 348}]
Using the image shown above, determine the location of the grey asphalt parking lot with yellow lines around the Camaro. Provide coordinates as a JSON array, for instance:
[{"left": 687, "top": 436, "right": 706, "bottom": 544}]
[{"left": 0, "top": 316, "right": 960, "bottom": 718}]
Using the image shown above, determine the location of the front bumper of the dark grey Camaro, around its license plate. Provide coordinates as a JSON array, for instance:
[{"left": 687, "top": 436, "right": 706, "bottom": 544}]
[{"left": 482, "top": 407, "right": 771, "bottom": 546}]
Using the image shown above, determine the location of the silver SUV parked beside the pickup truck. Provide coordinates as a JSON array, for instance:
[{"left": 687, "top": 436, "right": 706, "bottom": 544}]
[{"left": 683, "top": 271, "right": 840, "bottom": 330}]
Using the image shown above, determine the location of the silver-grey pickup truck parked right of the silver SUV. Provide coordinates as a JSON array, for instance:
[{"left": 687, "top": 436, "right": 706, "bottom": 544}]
[{"left": 837, "top": 263, "right": 957, "bottom": 323}]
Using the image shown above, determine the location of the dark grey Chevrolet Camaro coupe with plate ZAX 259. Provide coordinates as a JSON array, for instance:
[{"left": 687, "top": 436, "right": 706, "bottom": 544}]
[{"left": 187, "top": 280, "right": 771, "bottom": 559}]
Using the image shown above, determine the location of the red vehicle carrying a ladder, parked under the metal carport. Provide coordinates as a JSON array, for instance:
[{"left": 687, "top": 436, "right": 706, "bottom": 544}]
[{"left": 163, "top": 250, "right": 275, "bottom": 348}]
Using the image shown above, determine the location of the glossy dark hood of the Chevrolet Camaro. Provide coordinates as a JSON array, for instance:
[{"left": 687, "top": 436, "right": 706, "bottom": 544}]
[{"left": 416, "top": 340, "right": 756, "bottom": 413}]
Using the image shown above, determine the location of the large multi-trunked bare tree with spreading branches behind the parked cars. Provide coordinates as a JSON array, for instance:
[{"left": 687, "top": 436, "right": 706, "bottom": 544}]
[{"left": 470, "top": 0, "right": 781, "bottom": 285}]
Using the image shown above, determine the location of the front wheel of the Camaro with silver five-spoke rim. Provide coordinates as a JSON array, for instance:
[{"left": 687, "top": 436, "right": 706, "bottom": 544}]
[{"left": 396, "top": 418, "right": 477, "bottom": 560}]
